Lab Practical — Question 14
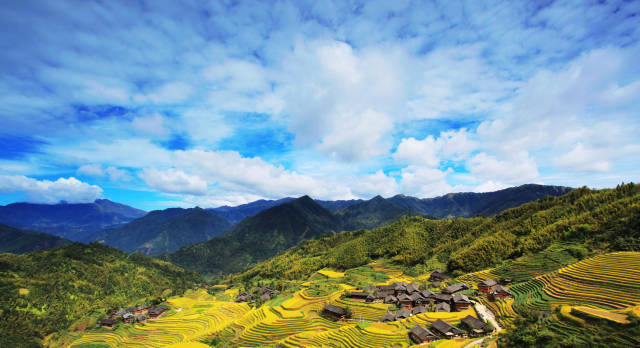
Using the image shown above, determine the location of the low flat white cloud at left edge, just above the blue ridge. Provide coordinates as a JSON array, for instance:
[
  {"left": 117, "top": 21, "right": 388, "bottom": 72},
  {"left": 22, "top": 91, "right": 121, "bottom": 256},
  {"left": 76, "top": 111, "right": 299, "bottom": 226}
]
[{"left": 0, "top": 175, "right": 102, "bottom": 203}]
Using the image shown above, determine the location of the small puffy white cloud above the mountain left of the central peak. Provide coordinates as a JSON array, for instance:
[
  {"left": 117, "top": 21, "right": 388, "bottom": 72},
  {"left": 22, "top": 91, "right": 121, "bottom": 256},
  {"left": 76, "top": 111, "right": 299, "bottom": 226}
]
[{"left": 140, "top": 168, "right": 207, "bottom": 195}]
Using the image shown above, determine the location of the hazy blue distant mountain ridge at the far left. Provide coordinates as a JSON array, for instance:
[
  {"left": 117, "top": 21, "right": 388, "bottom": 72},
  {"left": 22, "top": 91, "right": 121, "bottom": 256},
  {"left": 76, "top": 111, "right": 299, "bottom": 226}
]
[{"left": 0, "top": 199, "right": 146, "bottom": 241}]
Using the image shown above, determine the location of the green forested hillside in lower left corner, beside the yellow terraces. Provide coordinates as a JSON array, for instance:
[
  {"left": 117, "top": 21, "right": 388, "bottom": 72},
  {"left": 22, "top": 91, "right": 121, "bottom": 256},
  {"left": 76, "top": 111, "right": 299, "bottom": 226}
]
[{"left": 0, "top": 243, "right": 200, "bottom": 347}]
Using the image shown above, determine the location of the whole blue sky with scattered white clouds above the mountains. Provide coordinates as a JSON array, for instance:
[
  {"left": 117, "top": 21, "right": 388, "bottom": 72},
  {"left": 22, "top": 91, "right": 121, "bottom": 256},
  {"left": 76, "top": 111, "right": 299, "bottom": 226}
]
[{"left": 0, "top": 0, "right": 640, "bottom": 210}]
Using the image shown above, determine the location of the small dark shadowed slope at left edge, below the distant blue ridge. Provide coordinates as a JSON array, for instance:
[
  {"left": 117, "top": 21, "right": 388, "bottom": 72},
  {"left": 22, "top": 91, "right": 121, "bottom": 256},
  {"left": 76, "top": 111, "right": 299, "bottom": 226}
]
[{"left": 0, "top": 224, "right": 72, "bottom": 254}]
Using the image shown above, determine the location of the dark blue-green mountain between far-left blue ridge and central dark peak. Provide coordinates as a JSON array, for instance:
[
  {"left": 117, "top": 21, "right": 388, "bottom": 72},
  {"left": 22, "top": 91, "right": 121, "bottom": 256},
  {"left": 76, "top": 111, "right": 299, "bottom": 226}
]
[{"left": 93, "top": 207, "right": 231, "bottom": 255}]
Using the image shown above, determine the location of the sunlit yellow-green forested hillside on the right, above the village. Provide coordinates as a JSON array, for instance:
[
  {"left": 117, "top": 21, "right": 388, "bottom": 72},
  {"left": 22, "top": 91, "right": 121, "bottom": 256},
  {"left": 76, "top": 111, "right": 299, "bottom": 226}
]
[{"left": 236, "top": 183, "right": 640, "bottom": 279}]
